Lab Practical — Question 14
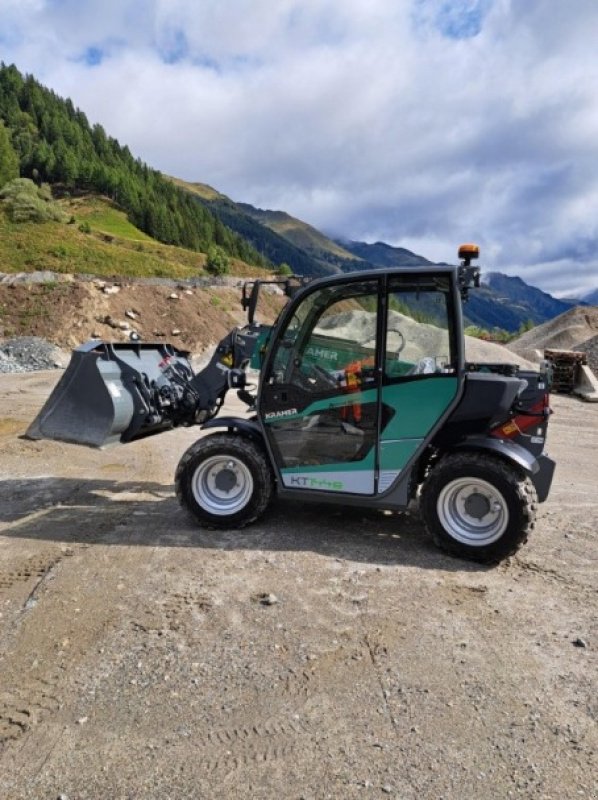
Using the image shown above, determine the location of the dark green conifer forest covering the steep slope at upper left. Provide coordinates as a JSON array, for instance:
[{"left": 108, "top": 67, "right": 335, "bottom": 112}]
[{"left": 0, "top": 64, "right": 268, "bottom": 266}]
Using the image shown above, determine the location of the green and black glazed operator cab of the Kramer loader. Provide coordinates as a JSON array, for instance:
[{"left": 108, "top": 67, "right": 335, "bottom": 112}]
[{"left": 258, "top": 268, "right": 462, "bottom": 495}]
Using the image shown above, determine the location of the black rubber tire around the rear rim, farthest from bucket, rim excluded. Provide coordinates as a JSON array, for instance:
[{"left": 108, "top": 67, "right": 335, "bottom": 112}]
[{"left": 420, "top": 451, "right": 538, "bottom": 564}]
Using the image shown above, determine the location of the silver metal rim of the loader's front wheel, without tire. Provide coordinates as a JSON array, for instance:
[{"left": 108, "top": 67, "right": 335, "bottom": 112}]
[{"left": 191, "top": 455, "right": 253, "bottom": 516}]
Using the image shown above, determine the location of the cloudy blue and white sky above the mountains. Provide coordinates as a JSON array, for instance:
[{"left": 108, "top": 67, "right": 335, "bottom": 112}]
[{"left": 0, "top": 0, "right": 598, "bottom": 295}]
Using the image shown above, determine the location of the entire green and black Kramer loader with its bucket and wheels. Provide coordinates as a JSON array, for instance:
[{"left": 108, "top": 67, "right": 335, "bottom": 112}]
[{"left": 27, "top": 245, "right": 555, "bottom": 563}]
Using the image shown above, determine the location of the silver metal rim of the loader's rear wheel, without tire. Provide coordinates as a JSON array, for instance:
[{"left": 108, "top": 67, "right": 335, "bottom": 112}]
[{"left": 436, "top": 478, "right": 509, "bottom": 547}]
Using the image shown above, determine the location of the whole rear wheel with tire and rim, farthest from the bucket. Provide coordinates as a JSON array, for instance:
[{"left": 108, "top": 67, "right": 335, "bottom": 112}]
[{"left": 420, "top": 452, "right": 538, "bottom": 563}]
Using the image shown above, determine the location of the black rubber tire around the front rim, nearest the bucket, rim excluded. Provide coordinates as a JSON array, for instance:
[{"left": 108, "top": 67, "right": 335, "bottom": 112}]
[{"left": 175, "top": 433, "right": 274, "bottom": 529}]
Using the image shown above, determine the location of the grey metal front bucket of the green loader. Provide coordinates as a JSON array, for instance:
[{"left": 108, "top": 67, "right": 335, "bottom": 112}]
[{"left": 25, "top": 340, "right": 193, "bottom": 447}]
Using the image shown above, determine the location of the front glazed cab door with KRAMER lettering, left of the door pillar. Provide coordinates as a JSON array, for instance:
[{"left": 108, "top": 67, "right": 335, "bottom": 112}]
[{"left": 258, "top": 278, "right": 382, "bottom": 495}]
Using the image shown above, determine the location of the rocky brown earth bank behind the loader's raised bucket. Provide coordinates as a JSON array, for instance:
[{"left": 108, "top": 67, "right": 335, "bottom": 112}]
[{"left": 0, "top": 273, "right": 283, "bottom": 353}]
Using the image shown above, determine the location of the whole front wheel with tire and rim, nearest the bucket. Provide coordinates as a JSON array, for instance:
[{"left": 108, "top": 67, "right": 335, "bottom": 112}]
[{"left": 175, "top": 433, "right": 274, "bottom": 528}]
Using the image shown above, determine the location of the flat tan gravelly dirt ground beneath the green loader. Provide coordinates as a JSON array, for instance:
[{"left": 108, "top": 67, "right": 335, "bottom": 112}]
[{"left": 0, "top": 373, "right": 598, "bottom": 800}]
